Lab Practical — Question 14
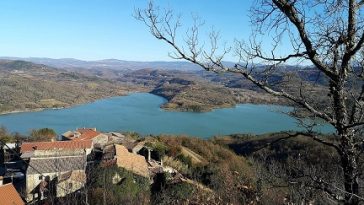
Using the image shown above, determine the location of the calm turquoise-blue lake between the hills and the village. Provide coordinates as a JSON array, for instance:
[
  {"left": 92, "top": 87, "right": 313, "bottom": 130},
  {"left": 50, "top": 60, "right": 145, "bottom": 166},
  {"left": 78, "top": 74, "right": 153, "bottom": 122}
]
[{"left": 0, "top": 93, "right": 333, "bottom": 137}]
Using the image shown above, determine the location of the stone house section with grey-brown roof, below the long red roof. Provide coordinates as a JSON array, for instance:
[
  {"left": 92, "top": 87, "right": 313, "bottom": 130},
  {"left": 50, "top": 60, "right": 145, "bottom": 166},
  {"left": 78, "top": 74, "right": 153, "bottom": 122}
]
[{"left": 26, "top": 154, "right": 87, "bottom": 202}]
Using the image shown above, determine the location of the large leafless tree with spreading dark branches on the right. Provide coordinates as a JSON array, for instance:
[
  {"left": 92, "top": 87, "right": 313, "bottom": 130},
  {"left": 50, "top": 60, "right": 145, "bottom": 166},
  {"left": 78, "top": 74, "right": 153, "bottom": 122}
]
[{"left": 136, "top": 0, "right": 364, "bottom": 204}]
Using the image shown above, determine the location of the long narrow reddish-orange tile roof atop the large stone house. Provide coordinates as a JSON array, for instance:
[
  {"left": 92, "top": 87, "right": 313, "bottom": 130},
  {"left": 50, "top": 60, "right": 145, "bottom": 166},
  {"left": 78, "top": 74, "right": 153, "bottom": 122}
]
[{"left": 20, "top": 140, "right": 92, "bottom": 153}]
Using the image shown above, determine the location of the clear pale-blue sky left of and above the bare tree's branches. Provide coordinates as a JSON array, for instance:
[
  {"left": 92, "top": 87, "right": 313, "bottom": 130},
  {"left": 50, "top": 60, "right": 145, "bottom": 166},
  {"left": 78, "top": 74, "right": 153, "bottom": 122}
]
[{"left": 0, "top": 0, "right": 252, "bottom": 61}]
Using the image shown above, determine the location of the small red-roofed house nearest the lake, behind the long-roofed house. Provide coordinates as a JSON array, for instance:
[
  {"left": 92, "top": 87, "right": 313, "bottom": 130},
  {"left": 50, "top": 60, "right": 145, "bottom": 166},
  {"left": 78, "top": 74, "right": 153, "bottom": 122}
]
[{"left": 62, "top": 128, "right": 109, "bottom": 148}]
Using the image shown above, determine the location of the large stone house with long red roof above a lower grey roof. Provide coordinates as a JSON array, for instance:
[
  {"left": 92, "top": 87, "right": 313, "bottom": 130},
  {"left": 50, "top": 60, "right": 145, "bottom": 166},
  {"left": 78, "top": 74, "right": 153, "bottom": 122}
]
[{"left": 20, "top": 140, "right": 93, "bottom": 202}]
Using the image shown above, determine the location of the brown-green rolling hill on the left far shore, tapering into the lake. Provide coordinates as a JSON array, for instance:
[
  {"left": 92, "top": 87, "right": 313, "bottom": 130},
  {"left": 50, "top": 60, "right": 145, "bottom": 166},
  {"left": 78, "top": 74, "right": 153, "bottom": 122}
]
[{"left": 0, "top": 60, "right": 134, "bottom": 113}]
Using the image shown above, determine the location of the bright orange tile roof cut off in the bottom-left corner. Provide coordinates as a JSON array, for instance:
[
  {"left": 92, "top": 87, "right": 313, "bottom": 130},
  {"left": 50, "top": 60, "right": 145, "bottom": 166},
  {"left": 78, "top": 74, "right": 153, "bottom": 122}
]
[{"left": 0, "top": 184, "right": 25, "bottom": 205}]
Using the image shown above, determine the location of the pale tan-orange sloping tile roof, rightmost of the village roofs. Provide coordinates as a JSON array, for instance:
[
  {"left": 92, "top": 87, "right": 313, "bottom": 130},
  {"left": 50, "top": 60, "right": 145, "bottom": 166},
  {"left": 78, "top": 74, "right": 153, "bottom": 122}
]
[{"left": 115, "top": 144, "right": 149, "bottom": 177}]
